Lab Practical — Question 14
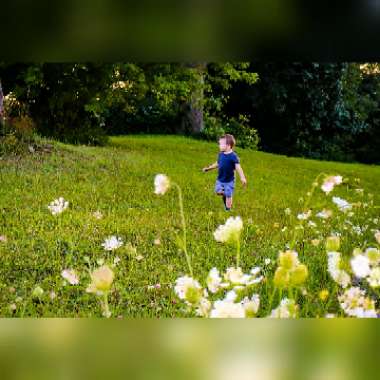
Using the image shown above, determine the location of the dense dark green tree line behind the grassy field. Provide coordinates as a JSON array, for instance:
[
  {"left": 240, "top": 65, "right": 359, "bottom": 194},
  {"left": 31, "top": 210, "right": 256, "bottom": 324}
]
[{"left": 0, "top": 62, "right": 380, "bottom": 163}]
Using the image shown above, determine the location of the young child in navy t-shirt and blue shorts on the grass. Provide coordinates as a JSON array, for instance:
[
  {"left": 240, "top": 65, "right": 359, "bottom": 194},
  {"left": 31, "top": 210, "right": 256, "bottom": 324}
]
[{"left": 202, "top": 134, "right": 247, "bottom": 211}]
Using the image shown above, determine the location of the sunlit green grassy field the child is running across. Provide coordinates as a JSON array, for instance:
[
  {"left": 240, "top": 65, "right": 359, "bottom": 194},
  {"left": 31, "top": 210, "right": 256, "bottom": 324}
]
[{"left": 0, "top": 136, "right": 380, "bottom": 317}]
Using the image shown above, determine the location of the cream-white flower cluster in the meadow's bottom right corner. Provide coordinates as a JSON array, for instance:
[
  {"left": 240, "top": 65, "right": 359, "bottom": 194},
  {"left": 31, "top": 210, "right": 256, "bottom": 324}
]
[{"left": 338, "top": 287, "right": 377, "bottom": 318}]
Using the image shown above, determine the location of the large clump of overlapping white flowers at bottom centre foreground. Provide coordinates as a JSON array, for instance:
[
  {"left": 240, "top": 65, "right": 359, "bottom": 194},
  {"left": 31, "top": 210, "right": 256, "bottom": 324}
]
[{"left": 174, "top": 267, "right": 263, "bottom": 318}]
